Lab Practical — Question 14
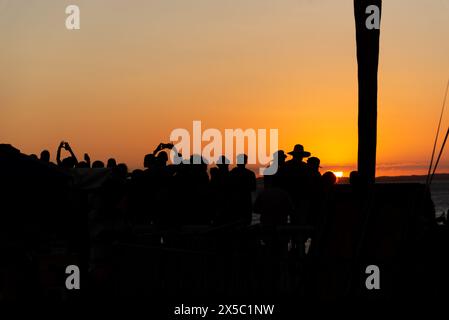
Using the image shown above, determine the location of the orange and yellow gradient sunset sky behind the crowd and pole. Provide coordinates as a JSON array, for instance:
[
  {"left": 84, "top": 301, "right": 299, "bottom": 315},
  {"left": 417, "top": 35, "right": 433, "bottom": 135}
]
[{"left": 0, "top": 0, "right": 449, "bottom": 175}]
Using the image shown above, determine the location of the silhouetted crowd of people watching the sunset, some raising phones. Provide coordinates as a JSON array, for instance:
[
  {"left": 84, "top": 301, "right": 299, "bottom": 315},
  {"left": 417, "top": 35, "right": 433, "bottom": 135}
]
[{"left": 25, "top": 141, "right": 344, "bottom": 227}]
